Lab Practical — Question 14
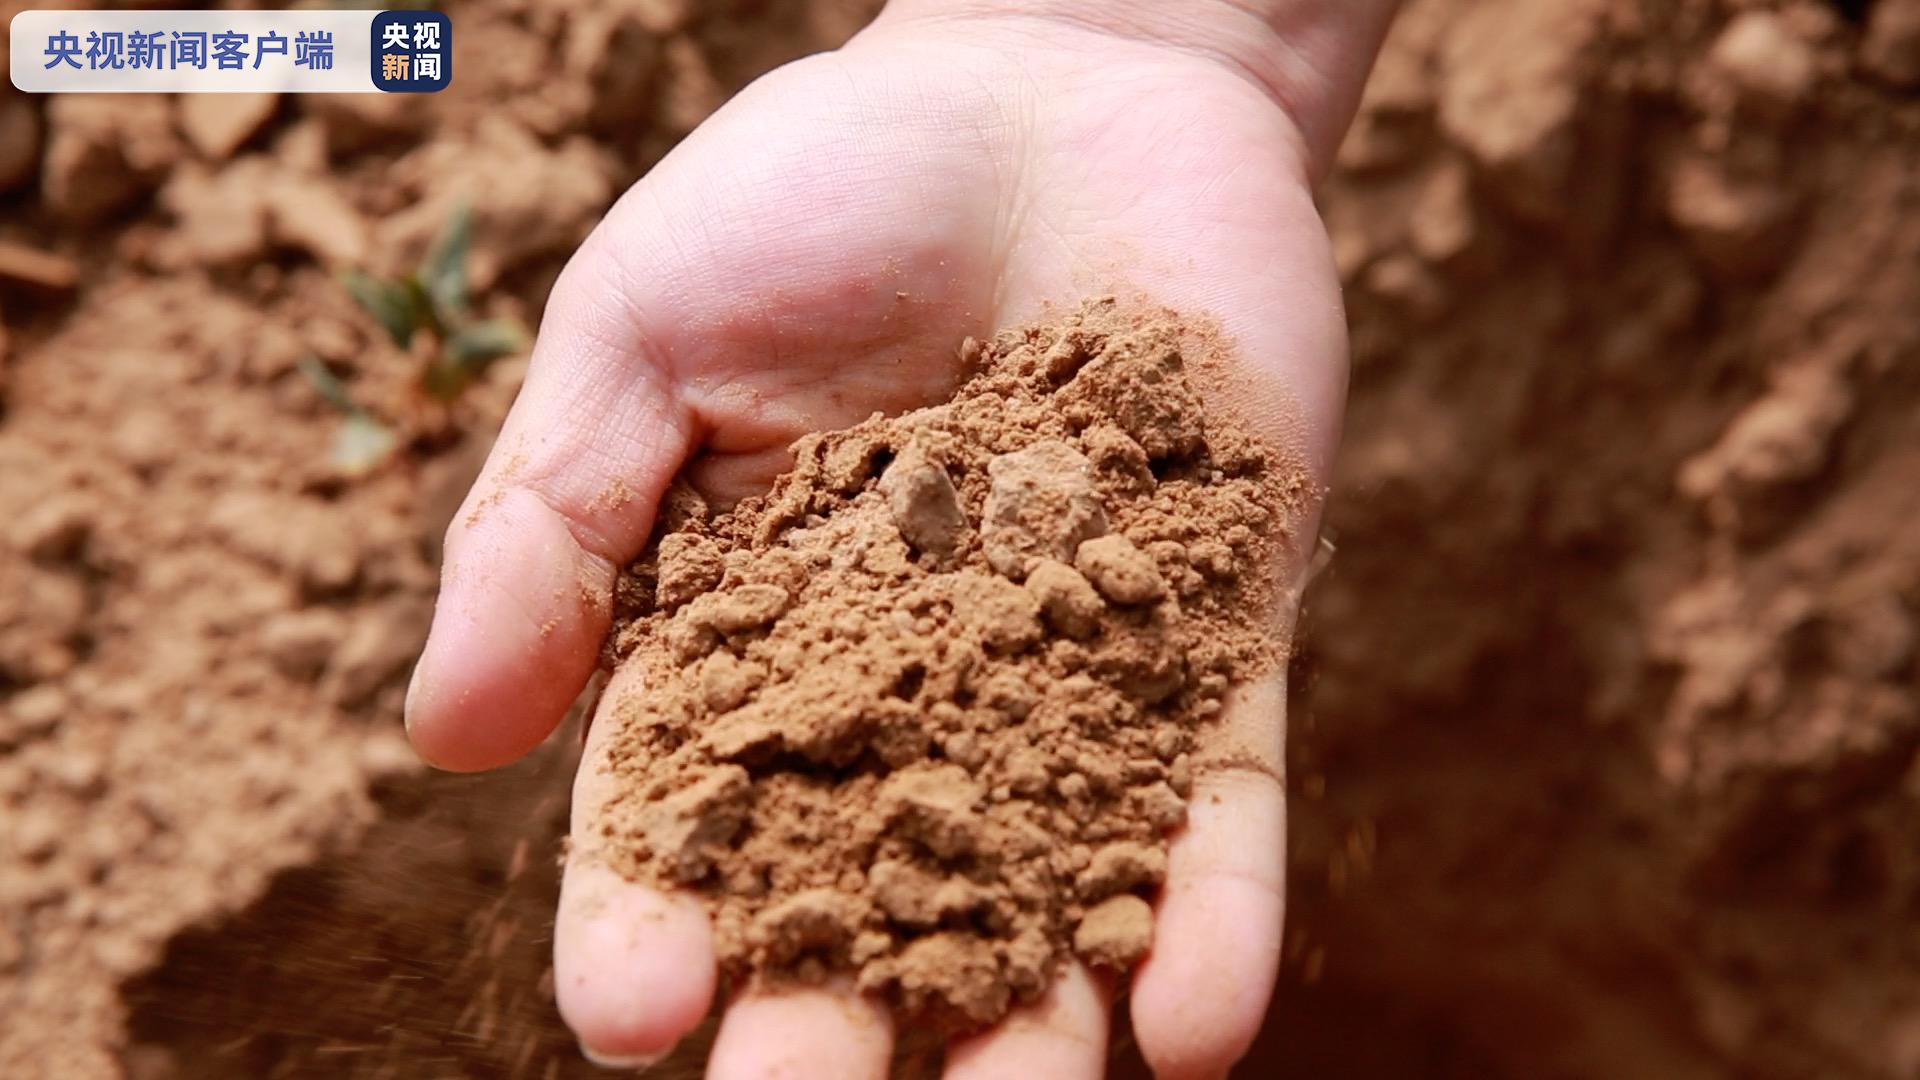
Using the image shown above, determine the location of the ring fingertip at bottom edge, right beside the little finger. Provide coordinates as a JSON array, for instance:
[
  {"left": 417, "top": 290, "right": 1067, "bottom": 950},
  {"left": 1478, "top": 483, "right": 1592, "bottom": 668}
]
[{"left": 945, "top": 963, "right": 1110, "bottom": 1080}]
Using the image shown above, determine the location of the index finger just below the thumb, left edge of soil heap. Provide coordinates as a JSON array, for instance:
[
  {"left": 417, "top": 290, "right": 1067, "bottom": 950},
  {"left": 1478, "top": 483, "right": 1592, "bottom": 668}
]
[{"left": 553, "top": 665, "right": 716, "bottom": 1065}]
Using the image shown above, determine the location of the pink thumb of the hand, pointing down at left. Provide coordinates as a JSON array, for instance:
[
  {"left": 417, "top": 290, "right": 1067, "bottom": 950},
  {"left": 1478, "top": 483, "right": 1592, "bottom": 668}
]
[{"left": 407, "top": 240, "right": 695, "bottom": 771}]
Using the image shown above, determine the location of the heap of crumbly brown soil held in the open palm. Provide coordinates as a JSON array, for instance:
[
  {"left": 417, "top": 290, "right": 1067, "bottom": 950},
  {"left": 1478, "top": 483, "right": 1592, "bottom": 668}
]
[{"left": 597, "top": 300, "right": 1302, "bottom": 1028}]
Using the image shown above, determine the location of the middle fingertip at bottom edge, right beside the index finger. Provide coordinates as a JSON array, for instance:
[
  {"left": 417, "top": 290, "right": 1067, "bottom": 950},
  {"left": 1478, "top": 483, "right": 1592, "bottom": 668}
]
[{"left": 707, "top": 984, "right": 893, "bottom": 1080}]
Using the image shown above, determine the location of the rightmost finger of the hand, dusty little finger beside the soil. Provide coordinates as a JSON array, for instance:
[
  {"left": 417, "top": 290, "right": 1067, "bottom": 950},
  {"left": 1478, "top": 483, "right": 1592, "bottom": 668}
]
[{"left": 1131, "top": 676, "right": 1286, "bottom": 1080}]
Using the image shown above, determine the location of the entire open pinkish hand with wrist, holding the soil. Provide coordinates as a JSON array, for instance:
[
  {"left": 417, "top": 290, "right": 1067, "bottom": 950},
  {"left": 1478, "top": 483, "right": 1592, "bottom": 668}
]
[{"left": 407, "top": 0, "right": 1392, "bottom": 1080}]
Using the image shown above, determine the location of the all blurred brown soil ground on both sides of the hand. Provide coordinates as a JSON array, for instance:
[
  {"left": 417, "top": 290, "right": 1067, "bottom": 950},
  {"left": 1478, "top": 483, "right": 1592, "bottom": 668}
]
[{"left": 0, "top": 0, "right": 1920, "bottom": 1078}]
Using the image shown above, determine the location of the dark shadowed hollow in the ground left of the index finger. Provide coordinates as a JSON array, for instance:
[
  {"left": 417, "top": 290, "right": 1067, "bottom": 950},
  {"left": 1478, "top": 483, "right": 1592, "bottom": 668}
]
[{"left": 121, "top": 744, "right": 579, "bottom": 1080}]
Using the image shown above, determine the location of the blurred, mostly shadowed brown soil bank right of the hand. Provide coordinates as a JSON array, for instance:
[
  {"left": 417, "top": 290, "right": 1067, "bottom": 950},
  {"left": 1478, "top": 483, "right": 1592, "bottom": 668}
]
[{"left": 1275, "top": 2, "right": 1920, "bottom": 1076}]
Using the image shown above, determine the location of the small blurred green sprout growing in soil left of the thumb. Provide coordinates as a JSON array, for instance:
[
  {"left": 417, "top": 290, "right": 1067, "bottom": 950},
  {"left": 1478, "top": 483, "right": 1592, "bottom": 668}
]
[{"left": 300, "top": 206, "right": 528, "bottom": 477}]
